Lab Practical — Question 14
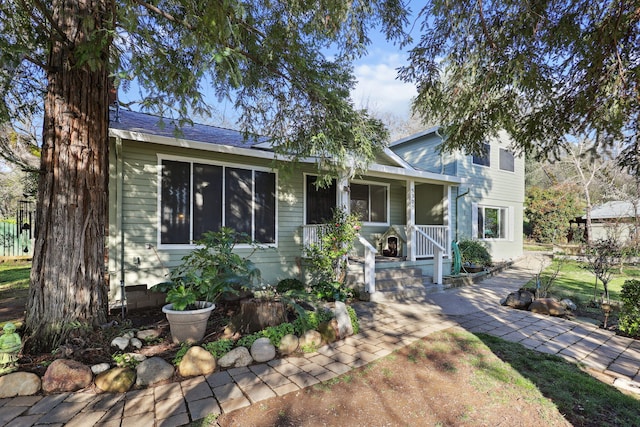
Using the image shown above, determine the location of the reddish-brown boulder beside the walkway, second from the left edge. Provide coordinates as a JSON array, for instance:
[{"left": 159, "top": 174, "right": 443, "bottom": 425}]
[{"left": 42, "top": 359, "right": 93, "bottom": 393}]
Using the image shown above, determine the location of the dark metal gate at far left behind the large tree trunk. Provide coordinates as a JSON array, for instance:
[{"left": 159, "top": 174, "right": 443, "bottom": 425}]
[{"left": 0, "top": 200, "right": 36, "bottom": 257}]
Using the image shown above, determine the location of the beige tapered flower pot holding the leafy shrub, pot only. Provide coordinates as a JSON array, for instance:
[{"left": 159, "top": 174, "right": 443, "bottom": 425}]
[{"left": 162, "top": 301, "right": 216, "bottom": 344}]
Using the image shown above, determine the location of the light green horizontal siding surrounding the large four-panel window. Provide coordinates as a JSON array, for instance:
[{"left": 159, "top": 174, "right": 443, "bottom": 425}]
[{"left": 109, "top": 139, "right": 304, "bottom": 299}]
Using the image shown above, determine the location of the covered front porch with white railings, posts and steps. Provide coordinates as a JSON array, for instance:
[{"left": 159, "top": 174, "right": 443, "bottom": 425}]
[{"left": 302, "top": 169, "right": 461, "bottom": 294}]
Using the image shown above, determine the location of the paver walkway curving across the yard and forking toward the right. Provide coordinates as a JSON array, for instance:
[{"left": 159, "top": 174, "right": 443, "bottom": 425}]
[{"left": 0, "top": 255, "right": 640, "bottom": 427}]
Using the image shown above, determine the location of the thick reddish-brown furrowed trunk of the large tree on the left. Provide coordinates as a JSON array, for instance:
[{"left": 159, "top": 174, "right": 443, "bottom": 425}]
[{"left": 25, "top": 0, "right": 114, "bottom": 352}]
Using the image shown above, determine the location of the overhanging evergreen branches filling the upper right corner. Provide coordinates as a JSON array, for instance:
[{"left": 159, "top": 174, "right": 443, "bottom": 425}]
[{"left": 400, "top": 0, "right": 640, "bottom": 175}]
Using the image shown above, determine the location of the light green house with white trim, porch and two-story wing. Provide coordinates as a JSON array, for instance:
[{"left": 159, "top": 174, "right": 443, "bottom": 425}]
[{"left": 108, "top": 110, "right": 524, "bottom": 304}]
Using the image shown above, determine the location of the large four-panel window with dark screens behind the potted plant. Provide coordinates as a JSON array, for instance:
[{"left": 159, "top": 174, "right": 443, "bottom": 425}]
[{"left": 160, "top": 159, "right": 276, "bottom": 245}]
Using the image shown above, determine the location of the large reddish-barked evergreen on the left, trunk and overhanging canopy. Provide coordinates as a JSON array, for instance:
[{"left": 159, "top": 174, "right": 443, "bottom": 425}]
[{"left": 0, "top": 0, "right": 406, "bottom": 351}]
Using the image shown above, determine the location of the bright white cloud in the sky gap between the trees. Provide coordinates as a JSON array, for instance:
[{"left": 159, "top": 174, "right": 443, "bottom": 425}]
[{"left": 351, "top": 54, "right": 417, "bottom": 118}]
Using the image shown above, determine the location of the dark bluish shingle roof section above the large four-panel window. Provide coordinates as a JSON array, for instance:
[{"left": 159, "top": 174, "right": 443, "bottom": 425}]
[{"left": 109, "top": 109, "right": 267, "bottom": 148}]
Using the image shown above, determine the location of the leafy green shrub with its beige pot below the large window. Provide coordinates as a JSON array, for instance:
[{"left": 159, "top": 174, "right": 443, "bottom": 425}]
[{"left": 153, "top": 227, "right": 260, "bottom": 343}]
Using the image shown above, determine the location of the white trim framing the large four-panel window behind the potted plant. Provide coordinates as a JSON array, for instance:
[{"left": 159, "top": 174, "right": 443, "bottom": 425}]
[{"left": 156, "top": 153, "right": 280, "bottom": 250}]
